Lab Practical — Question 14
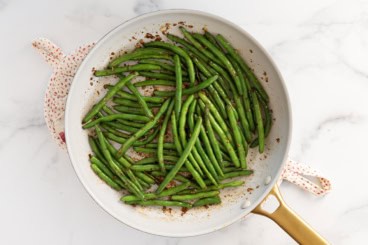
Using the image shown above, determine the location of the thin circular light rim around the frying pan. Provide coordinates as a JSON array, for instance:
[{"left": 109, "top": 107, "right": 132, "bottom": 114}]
[{"left": 65, "top": 9, "right": 292, "bottom": 238}]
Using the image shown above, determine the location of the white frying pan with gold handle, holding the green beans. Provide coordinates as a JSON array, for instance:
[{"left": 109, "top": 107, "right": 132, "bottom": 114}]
[{"left": 65, "top": 10, "right": 327, "bottom": 244}]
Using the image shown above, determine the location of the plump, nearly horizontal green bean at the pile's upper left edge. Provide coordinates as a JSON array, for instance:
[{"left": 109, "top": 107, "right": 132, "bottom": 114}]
[{"left": 108, "top": 48, "right": 170, "bottom": 67}]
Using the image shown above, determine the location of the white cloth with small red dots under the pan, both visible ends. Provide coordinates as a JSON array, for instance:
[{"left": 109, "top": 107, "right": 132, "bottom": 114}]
[{"left": 32, "top": 38, "right": 331, "bottom": 196}]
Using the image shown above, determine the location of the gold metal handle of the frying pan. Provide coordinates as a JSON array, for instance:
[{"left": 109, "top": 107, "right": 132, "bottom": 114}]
[{"left": 252, "top": 185, "right": 328, "bottom": 245}]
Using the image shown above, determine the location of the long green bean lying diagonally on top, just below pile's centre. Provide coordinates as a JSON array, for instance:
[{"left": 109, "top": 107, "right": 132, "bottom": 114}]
[{"left": 156, "top": 118, "right": 202, "bottom": 193}]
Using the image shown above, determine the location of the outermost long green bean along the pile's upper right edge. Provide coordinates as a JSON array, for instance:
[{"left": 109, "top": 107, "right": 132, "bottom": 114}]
[{"left": 216, "top": 34, "right": 269, "bottom": 102}]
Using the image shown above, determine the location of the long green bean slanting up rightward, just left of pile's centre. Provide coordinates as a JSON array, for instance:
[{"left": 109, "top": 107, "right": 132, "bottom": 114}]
[{"left": 117, "top": 100, "right": 170, "bottom": 157}]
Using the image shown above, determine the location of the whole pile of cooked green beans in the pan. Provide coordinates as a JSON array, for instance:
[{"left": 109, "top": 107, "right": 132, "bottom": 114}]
[{"left": 82, "top": 27, "right": 272, "bottom": 211}]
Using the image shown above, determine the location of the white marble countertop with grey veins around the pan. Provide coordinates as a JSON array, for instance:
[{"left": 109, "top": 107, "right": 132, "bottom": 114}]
[{"left": 0, "top": 0, "right": 368, "bottom": 245}]
